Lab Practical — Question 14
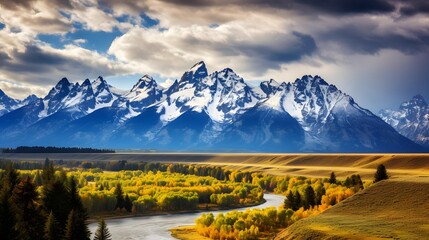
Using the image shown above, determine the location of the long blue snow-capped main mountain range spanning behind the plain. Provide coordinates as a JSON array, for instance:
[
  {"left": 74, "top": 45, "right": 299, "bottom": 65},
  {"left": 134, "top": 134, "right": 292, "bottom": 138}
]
[{"left": 0, "top": 62, "right": 427, "bottom": 152}]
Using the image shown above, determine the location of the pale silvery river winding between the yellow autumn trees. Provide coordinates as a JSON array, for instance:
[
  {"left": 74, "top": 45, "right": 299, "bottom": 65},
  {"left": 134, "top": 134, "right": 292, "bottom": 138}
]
[{"left": 89, "top": 194, "right": 284, "bottom": 240}]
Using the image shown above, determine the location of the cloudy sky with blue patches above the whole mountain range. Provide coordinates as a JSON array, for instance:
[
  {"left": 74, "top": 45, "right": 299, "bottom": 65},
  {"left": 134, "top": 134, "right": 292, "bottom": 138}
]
[{"left": 0, "top": 0, "right": 429, "bottom": 112}]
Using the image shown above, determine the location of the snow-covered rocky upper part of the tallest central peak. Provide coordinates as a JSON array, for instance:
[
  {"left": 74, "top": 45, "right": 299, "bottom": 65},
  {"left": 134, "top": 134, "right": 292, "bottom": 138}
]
[{"left": 159, "top": 62, "right": 263, "bottom": 123}]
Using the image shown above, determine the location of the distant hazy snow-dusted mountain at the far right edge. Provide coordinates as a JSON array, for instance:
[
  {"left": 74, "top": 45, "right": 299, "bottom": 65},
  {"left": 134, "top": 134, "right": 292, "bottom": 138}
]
[{"left": 379, "top": 95, "right": 429, "bottom": 147}]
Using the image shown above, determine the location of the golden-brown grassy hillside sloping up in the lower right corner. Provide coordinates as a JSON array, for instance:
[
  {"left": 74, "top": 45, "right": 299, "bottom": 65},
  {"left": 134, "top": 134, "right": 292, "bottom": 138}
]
[{"left": 276, "top": 177, "right": 429, "bottom": 239}]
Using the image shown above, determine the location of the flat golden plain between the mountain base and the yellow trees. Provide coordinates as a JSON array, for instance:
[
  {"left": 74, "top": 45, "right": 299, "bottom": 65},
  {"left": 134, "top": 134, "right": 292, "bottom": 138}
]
[{"left": 0, "top": 152, "right": 429, "bottom": 179}]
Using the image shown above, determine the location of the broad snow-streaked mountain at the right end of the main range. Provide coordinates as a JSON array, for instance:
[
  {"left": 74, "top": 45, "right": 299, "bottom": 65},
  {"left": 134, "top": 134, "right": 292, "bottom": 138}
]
[{"left": 263, "top": 76, "right": 422, "bottom": 152}]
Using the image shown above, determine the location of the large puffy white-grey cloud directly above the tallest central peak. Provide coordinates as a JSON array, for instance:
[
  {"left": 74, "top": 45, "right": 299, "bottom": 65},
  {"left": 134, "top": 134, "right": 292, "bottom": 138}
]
[{"left": 108, "top": 14, "right": 316, "bottom": 78}]
